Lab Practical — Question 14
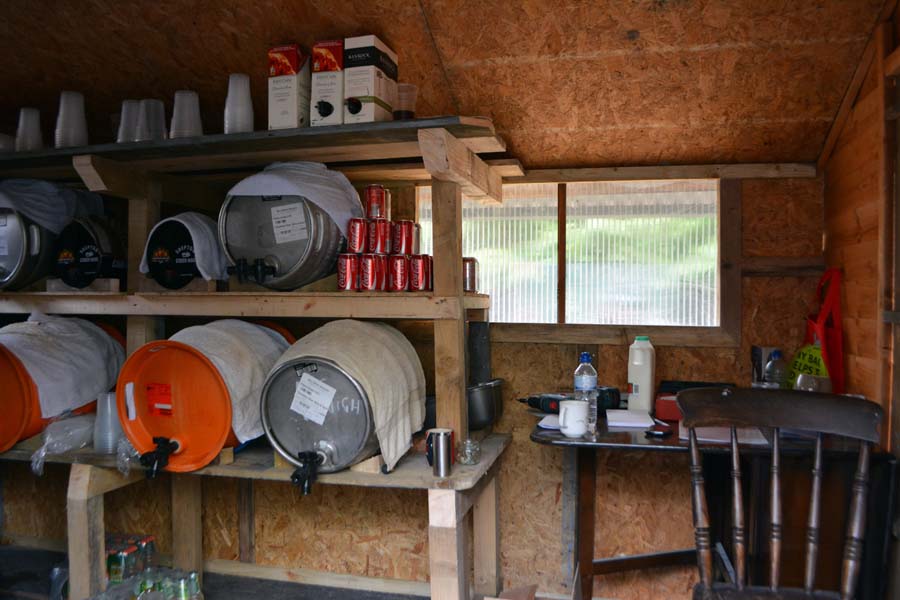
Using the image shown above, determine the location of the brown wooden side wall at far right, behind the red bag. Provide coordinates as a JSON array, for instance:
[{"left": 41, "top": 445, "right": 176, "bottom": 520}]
[{"left": 825, "top": 50, "right": 884, "bottom": 398}]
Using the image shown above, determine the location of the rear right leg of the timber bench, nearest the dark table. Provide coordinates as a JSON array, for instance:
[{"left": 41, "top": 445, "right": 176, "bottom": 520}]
[{"left": 472, "top": 473, "right": 503, "bottom": 596}]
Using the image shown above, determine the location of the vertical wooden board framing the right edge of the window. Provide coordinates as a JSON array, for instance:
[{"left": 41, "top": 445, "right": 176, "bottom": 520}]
[{"left": 719, "top": 179, "right": 743, "bottom": 344}]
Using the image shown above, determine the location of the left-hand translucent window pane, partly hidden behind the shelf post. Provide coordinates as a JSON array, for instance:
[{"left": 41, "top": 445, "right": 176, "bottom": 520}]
[{"left": 419, "top": 184, "right": 557, "bottom": 323}]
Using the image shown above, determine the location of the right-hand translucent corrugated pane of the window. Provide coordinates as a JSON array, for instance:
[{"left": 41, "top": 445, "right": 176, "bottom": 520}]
[{"left": 566, "top": 180, "right": 719, "bottom": 327}]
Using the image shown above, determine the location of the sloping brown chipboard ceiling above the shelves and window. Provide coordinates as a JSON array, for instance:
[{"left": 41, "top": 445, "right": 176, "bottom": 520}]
[{"left": 0, "top": 0, "right": 882, "bottom": 167}]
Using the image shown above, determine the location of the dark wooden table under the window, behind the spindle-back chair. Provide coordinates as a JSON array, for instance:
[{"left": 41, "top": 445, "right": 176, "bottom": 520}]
[{"left": 531, "top": 420, "right": 896, "bottom": 599}]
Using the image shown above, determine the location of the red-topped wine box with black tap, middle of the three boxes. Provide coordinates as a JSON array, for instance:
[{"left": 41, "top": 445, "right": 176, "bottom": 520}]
[{"left": 309, "top": 40, "right": 344, "bottom": 127}]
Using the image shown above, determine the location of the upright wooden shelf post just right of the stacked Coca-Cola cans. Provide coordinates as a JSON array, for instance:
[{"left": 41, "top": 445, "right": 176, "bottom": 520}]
[{"left": 431, "top": 180, "right": 469, "bottom": 441}]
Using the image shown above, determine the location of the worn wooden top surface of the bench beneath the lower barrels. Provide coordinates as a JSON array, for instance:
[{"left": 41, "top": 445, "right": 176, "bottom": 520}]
[{"left": 0, "top": 433, "right": 511, "bottom": 491}]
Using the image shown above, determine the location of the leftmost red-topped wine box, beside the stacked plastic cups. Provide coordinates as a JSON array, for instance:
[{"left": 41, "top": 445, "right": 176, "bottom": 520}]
[{"left": 269, "top": 44, "right": 310, "bottom": 129}]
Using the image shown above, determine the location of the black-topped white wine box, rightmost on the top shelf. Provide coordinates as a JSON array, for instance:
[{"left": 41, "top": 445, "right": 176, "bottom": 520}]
[{"left": 344, "top": 35, "right": 397, "bottom": 123}]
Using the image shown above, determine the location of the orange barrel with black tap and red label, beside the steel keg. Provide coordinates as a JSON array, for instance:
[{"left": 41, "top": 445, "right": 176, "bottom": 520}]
[{"left": 116, "top": 322, "right": 293, "bottom": 473}]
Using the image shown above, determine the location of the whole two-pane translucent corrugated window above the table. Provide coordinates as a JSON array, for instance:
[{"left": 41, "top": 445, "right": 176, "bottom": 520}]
[{"left": 418, "top": 179, "right": 723, "bottom": 336}]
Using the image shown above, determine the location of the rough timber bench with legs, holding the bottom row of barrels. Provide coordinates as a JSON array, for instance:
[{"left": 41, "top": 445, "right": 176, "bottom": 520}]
[{"left": 0, "top": 434, "right": 510, "bottom": 600}]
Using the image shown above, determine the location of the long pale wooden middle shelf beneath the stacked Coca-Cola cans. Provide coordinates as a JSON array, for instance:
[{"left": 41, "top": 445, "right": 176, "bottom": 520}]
[{"left": 0, "top": 292, "right": 491, "bottom": 320}]
